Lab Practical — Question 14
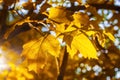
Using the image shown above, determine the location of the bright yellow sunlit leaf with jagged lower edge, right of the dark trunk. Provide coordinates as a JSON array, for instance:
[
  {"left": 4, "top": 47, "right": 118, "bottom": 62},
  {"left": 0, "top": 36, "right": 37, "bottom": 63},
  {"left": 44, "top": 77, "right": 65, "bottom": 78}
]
[{"left": 69, "top": 33, "right": 97, "bottom": 59}]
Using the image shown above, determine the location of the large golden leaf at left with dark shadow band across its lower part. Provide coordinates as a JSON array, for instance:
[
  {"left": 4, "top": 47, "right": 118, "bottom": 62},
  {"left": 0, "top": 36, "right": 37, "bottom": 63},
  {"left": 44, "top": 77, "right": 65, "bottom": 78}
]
[{"left": 22, "top": 35, "right": 60, "bottom": 73}]
